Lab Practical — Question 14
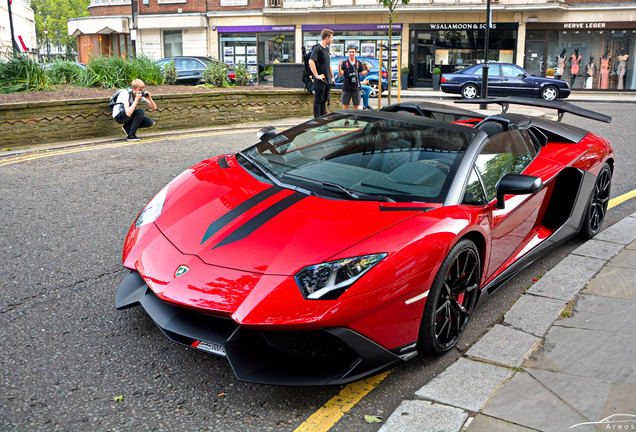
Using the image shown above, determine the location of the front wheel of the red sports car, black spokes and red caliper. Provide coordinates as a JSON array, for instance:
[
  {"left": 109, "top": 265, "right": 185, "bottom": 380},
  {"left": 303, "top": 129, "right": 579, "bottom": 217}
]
[{"left": 417, "top": 239, "right": 481, "bottom": 355}]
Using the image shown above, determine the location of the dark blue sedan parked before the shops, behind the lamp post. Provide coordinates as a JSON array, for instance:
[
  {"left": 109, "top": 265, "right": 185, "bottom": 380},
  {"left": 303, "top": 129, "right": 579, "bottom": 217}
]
[{"left": 441, "top": 63, "right": 570, "bottom": 100}]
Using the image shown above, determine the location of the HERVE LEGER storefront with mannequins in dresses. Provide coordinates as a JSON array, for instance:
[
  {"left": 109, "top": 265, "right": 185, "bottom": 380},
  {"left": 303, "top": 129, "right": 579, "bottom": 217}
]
[{"left": 524, "top": 22, "right": 636, "bottom": 90}]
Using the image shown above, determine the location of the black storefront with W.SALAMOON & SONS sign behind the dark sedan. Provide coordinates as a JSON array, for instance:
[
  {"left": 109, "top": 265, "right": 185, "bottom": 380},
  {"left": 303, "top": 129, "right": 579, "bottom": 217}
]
[{"left": 409, "top": 23, "right": 519, "bottom": 87}]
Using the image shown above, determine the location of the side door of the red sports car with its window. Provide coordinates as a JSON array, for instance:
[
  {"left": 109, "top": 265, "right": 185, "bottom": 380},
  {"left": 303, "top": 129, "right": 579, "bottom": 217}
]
[{"left": 464, "top": 129, "right": 545, "bottom": 279}]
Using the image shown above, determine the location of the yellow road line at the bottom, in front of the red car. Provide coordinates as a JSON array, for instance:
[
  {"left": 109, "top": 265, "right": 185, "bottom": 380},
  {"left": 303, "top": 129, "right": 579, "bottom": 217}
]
[{"left": 294, "top": 371, "right": 391, "bottom": 432}]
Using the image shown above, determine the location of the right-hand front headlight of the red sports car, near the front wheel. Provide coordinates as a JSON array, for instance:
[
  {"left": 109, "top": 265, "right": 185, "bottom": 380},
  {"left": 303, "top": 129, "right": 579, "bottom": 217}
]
[{"left": 295, "top": 253, "right": 387, "bottom": 300}]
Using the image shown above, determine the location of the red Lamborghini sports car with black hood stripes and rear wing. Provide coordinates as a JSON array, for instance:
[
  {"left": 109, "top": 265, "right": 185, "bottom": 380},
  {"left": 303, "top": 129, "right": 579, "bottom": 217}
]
[{"left": 116, "top": 99, "right": 614, "bottom": 385}]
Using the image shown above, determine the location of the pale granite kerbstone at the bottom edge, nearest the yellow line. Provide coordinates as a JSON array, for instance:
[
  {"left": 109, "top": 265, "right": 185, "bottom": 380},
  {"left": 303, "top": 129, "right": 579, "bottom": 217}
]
[{"left": 378, "top": 400, "right": 468, "bottom": 432}]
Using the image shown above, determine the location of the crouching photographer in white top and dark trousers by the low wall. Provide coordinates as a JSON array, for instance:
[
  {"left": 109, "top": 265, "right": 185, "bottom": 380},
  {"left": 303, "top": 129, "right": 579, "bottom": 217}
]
[{"left": 111, "top": 79, "right": 157, "bottom": 141}]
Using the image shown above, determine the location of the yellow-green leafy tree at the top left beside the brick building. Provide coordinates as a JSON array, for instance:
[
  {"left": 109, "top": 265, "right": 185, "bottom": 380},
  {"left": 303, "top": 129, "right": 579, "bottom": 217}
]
[{"left": 31, "top": 0, "right": 90, "bottom": 59}]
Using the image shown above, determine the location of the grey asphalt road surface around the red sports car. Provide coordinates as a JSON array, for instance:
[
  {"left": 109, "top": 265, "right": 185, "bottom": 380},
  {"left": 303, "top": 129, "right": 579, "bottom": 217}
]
[{"left": 0, "top": 103, "right": 636, "bottom": 431}]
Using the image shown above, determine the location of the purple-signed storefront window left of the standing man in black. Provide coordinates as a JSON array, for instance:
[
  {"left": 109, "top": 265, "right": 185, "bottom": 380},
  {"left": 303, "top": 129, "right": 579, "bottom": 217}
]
[{"left": 217, "top": 25, "right": 300, "bottom": 76}]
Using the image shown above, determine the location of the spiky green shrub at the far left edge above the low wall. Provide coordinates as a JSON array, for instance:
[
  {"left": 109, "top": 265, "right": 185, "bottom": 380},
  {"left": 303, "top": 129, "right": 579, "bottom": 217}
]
[{"left": 0, "top": 54, "right": 54, "bottom": 93}]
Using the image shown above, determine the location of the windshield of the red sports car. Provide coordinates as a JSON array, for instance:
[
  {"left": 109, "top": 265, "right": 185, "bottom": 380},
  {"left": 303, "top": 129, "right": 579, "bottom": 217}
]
[{"left": 238, "top": 113, "right": 474, "bottom": 202}]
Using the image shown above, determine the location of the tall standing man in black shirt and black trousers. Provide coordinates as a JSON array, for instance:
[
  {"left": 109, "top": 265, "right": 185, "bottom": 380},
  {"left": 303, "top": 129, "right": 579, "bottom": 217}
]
[{"left": 309, "top": 29, "right": 335, "bottom": 118}]
